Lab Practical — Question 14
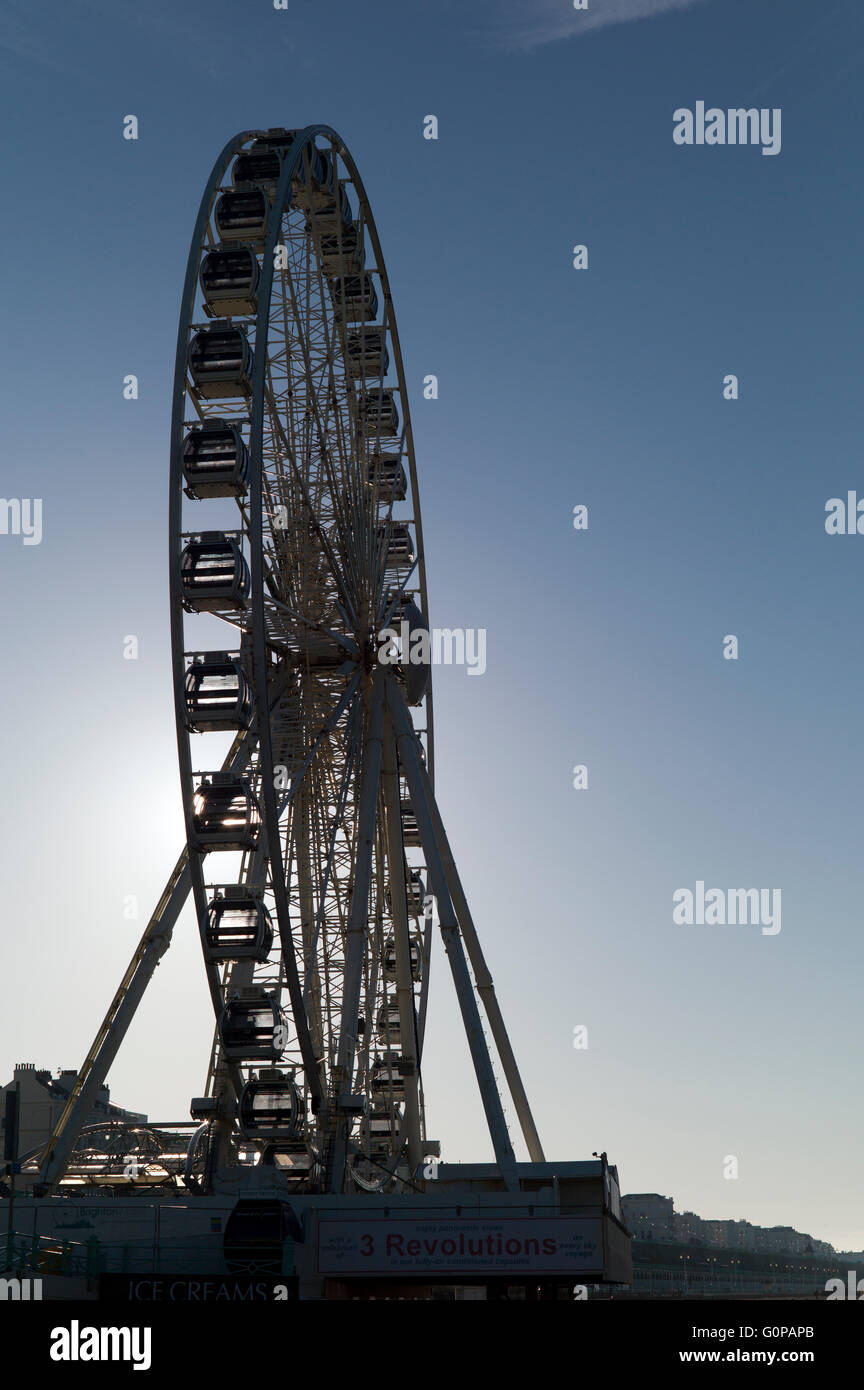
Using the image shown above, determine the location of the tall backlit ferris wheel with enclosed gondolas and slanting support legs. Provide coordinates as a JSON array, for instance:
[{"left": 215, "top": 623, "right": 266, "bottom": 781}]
[{"left": 40, "top": 125, "right": 543, "bottom": 1193}]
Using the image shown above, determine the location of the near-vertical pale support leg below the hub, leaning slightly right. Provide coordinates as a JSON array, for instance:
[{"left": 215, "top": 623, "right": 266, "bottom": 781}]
[{"left": 381, "top": 717, "right": 424, "bottom": 1173}]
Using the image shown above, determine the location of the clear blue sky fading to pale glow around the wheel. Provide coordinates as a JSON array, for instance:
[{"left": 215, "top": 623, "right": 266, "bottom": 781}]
[{"left": 0, "top": 0, "right": 864, "bottom": 1250}]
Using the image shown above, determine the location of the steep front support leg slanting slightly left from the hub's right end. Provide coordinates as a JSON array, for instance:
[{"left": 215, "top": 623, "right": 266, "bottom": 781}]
[{"left": 328, "top": 669, "right": 385, "bottom": 1193}]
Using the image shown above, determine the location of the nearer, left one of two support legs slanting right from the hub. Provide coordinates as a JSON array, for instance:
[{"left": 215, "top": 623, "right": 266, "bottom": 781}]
[{"left": 388, "top": 677, "right": 520, "bottom": 1191}]
